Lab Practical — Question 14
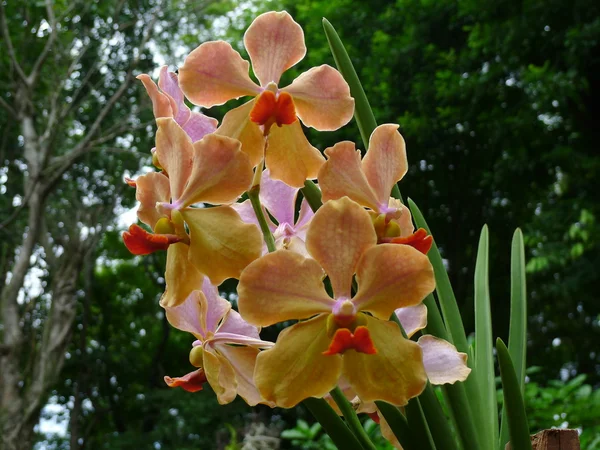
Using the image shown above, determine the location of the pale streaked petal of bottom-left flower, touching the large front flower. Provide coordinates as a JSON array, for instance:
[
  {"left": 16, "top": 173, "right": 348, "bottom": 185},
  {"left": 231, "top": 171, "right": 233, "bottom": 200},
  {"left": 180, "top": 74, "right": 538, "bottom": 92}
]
[{"left": 215, "top": 344, "right": 274, "bottom": 406}]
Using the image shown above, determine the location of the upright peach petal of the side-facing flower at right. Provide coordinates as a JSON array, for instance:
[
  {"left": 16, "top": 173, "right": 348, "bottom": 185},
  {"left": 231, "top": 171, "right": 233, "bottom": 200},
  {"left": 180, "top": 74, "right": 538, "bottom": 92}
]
[{"left": 362, "top": 124, "right": 408, "bottom": 206}]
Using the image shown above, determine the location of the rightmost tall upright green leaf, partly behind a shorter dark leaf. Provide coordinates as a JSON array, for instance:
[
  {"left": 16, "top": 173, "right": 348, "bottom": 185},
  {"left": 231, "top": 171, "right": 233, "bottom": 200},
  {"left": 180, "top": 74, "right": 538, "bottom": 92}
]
[{"left": 500, "top": 228, "right": 527, "bottom": 448}]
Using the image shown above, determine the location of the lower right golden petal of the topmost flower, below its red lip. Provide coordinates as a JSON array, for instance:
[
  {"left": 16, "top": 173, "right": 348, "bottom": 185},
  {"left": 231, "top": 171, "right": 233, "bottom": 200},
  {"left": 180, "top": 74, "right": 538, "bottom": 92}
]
[{"left": 265, "top": 121, "right": 325, "bottom": 188}]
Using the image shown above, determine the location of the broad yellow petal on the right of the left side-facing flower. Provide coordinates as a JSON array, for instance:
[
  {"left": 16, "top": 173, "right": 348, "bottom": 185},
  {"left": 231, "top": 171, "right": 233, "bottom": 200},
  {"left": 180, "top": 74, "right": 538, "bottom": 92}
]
[{"left": 181, "top": 206, "right": 262, "bottom": 286}]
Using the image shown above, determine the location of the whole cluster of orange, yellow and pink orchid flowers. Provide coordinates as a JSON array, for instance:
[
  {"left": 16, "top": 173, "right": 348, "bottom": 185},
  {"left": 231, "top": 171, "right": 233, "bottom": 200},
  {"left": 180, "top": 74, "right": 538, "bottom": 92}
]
[{"left": 123, "top": 12, "right": 470, "bottom": 446}]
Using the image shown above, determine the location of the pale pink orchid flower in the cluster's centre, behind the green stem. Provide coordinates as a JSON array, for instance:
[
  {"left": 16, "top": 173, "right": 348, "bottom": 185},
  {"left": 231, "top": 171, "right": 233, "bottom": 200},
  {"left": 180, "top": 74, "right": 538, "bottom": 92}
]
[{"left": 232, "top": 169, "right": 314, "bottom": 256}]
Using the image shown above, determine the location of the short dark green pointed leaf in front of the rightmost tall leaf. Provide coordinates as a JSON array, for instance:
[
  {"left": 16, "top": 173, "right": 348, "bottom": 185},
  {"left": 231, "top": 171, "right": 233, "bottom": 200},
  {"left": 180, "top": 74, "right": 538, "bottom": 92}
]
[{"left": 496, "top": 338, "right": 532, "bottom": 450}]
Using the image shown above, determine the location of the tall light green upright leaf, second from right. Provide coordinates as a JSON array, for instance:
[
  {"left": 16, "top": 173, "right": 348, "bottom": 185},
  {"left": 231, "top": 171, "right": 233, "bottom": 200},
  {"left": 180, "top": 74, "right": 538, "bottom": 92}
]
[{"left": 471, "top": 225, "right": 498, "bottom": 449}]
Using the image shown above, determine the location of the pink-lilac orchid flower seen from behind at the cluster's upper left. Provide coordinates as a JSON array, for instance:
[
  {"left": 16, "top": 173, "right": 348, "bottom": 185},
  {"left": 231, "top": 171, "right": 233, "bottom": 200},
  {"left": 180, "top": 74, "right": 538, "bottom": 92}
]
[{"left": 137, "top": 66, "right": 218, "bottom": 142}]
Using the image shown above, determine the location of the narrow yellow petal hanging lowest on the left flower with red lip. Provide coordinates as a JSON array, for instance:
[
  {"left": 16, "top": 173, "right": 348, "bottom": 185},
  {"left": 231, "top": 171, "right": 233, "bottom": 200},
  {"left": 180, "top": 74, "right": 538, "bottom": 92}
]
[{"left": 160, "top": 242, "right": 204, "bottom": 308}]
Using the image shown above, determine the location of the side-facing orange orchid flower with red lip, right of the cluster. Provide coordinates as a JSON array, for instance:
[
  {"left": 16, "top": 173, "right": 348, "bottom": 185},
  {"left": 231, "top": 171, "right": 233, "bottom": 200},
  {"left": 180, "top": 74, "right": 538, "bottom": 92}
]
[{"left": 318, "top": 124, "right": 432, "bottom": 253}]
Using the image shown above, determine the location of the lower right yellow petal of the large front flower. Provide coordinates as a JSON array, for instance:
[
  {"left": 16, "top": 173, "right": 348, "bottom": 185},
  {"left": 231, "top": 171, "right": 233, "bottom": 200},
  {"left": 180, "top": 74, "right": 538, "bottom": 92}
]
[{"left": 343, "top": 316, "right": 427, "bottom": 406}]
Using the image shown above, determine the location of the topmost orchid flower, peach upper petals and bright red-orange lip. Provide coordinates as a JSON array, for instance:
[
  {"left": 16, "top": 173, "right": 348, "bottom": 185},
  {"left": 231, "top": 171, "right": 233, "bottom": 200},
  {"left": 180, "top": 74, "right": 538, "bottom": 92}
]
[{"left": 179, "top": 11, "right": 354, "bottom": 187}]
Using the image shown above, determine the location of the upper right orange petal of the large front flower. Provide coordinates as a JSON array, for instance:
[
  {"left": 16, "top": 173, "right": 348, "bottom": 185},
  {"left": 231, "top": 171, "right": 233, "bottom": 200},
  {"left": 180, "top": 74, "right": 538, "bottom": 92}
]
[{"left": 352, "top": 244, "right": 435, "bottom": 320}]
